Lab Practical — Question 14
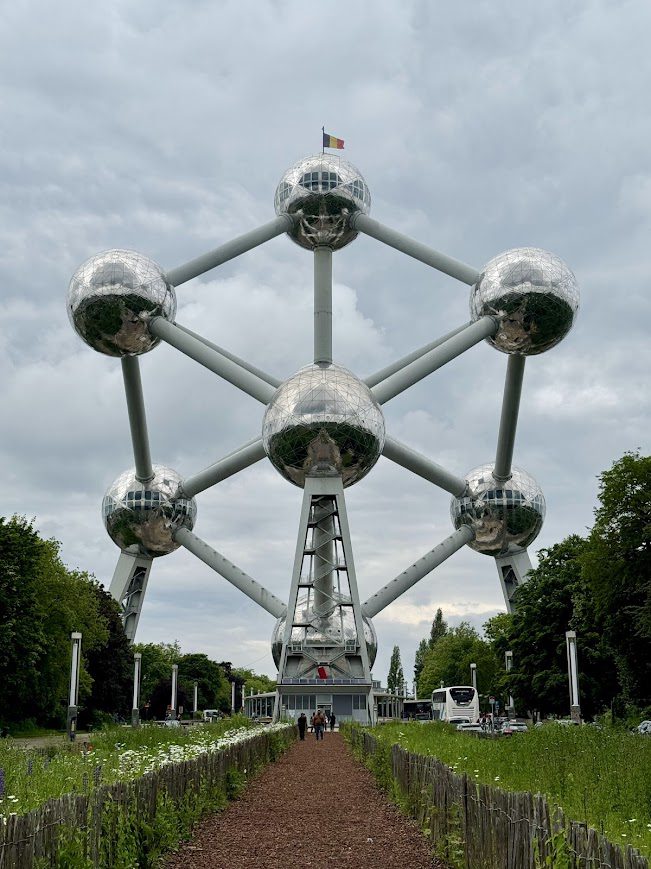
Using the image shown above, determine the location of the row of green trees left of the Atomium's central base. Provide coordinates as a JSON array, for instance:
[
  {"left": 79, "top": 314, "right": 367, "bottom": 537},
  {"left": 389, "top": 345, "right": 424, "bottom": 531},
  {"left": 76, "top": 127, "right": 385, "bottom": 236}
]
[{"left": 0, "top": 516, "right": 275, "bottom": 731}]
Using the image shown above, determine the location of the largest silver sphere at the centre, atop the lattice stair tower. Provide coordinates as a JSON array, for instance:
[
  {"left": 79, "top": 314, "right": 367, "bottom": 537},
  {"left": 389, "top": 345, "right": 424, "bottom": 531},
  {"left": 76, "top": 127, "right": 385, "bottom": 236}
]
[{"left": 262, "top": 364, "right": 385, "bottom": 487}]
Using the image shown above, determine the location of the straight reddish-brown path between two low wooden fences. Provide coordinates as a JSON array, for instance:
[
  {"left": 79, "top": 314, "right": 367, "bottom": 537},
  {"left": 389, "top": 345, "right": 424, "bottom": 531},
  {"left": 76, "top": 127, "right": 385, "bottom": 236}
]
[{"left": 165, "top": 733, "right": 443, "bottom": 869}]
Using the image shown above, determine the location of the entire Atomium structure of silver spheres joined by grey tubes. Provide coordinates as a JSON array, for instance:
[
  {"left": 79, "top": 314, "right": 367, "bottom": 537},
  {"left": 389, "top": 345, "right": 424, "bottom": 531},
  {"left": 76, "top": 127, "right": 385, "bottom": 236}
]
[{"left": 68, "top": 154, "right": 579, "bottom": 721}]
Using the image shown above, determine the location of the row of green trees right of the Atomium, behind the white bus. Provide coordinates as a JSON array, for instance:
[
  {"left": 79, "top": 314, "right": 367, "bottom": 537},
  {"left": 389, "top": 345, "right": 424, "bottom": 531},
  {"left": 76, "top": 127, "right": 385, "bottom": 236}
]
[{"left": 392, "top": 452, "right": 651, "bottom": 719}]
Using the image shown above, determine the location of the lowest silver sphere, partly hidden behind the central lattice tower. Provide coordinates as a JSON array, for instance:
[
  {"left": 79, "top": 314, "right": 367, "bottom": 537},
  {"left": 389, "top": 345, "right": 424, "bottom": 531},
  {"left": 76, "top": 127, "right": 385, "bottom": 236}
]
[{"left": 271, "top": 597, "right": 377, "bottom": 667}]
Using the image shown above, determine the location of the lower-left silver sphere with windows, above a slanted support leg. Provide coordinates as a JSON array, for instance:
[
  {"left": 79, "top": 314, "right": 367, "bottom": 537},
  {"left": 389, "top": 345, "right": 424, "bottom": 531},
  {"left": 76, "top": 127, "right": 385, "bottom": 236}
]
[{"left": 102, "top": 465, "right": 197, "bottom": 557}]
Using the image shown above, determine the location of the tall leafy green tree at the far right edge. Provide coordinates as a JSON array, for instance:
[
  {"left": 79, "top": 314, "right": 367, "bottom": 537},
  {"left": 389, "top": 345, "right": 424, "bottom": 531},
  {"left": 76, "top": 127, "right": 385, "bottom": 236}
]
[{"left": 581, "top": 452, "right": 651, "bottom": 705}]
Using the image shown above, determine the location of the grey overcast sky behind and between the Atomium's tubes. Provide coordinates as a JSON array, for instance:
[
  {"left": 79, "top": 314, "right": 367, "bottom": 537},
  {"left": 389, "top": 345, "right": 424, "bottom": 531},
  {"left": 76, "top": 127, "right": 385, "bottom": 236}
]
[{"left": 0, "top": 0, "right": 651, "bottom": 682}]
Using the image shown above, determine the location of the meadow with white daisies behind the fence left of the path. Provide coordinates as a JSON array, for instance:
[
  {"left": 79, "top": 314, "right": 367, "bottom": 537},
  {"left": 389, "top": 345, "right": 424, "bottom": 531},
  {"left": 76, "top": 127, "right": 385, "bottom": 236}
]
[{"left": 0, "top": 716, "right": 252, "bottom": 821}]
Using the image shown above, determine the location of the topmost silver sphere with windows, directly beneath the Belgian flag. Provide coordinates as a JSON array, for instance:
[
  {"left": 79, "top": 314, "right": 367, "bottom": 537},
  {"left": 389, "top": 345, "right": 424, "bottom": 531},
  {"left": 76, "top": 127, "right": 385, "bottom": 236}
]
[{"left": 274, "top": 154, "right": 371, "bottom": 250}]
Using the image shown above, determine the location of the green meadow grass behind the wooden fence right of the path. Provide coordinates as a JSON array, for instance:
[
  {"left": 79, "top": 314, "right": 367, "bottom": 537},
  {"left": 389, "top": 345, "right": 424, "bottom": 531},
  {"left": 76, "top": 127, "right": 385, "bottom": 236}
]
[{"left": 372, "top": 723, "right": 651, "bottom": 856}]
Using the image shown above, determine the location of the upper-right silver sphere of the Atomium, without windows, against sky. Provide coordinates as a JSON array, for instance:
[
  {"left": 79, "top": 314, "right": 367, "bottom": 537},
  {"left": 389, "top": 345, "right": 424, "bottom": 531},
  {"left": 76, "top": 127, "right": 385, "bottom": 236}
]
[{"left": 470, "top": 247, "right": 579, "bottom": 356}]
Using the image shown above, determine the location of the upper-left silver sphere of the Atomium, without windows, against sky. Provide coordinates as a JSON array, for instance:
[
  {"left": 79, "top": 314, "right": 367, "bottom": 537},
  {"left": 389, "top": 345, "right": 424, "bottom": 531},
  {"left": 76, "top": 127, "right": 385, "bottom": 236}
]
[{"left": 68, "top": 250, "right": 176, "bottom": 356}]
